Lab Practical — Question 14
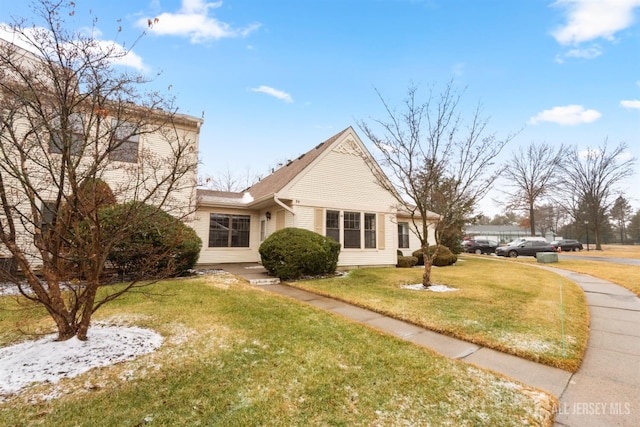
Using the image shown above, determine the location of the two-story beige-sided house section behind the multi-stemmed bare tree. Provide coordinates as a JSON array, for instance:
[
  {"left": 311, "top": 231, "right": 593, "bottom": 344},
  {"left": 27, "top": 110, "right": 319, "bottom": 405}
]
[{"left": 0, "top": 39, "right": 203, "bottom": 264}]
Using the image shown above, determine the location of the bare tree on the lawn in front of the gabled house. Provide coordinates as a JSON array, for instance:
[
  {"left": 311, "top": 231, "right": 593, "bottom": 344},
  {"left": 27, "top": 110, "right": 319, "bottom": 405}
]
[{"left": 358, "top": 82, "right": 515, "bottom": 287}]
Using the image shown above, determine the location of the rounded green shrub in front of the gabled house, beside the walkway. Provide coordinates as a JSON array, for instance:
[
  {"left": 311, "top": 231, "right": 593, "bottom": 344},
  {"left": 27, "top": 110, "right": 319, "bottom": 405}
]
[{"left": 259, "top": 228, "right": 340, "bottom": 280}]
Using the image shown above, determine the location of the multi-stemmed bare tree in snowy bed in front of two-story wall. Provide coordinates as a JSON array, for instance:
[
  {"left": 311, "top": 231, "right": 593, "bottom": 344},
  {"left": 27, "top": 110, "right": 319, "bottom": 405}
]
[{"left": 0, "top": 0, "right": 201, "bottom": 340}]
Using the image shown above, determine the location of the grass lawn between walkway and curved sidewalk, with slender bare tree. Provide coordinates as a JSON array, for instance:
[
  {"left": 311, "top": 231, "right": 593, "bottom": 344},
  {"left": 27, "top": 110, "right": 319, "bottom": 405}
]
[{"left": 292, "top": 256, "right": 589, "bottom": 372}]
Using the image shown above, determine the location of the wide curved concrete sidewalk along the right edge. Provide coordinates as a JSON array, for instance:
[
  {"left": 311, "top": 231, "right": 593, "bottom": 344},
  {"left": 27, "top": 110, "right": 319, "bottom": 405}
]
[{"left": 542, "top": 267, "right": 640, "bottom": 427}]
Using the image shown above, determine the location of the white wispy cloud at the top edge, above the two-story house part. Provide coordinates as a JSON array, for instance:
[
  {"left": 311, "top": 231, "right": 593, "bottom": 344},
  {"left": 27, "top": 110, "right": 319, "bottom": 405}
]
[{"left": 136, "top": 0, "right": 260, "bottom": 43}]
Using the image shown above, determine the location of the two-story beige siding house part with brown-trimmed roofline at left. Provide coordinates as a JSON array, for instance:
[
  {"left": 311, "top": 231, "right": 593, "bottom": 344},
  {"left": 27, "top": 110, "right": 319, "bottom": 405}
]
[{"left": 0, "top": 39, "right": 203, "bottom": 262}]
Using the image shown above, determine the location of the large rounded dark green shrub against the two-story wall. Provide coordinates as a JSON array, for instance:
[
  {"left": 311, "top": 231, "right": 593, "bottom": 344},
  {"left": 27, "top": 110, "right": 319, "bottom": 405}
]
[{"left": 101, "top": 202, "right": 202, "bottom": 278}]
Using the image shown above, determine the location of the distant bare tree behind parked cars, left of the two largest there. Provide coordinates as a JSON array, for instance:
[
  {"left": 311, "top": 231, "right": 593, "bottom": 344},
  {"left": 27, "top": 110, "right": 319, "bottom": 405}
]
[{"left": 504, "top": 143, "right": 570, "bottom": 236}]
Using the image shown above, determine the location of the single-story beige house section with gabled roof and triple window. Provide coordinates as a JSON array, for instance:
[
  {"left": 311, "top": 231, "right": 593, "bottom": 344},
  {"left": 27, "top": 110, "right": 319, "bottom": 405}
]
[{"left": 189, "top": 127, "right": 437, "bottom": 269}]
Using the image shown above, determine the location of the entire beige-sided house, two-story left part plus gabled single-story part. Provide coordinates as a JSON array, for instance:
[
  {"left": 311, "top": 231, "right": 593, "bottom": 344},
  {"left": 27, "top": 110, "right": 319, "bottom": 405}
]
[{"left": 0, "top": 38, "right": 437, "bottom": 268}]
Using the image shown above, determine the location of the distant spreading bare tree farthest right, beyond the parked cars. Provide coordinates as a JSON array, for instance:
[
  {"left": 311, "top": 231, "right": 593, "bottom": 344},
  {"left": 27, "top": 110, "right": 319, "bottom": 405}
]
[{"left": 565, "top": 140, "right": 635, "bottom": 250}]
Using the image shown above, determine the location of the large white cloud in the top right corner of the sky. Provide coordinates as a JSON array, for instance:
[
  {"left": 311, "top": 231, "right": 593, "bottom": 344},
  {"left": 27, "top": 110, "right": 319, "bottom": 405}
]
[{"left": 552, "top": 0, "right": 640, "bottom": 45}]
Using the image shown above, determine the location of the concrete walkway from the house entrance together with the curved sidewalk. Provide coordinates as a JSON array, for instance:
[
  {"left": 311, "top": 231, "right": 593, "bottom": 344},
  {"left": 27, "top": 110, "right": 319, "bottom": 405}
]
[{"left": 217, "top": 264, "right": 640, "bottom": 427}]
